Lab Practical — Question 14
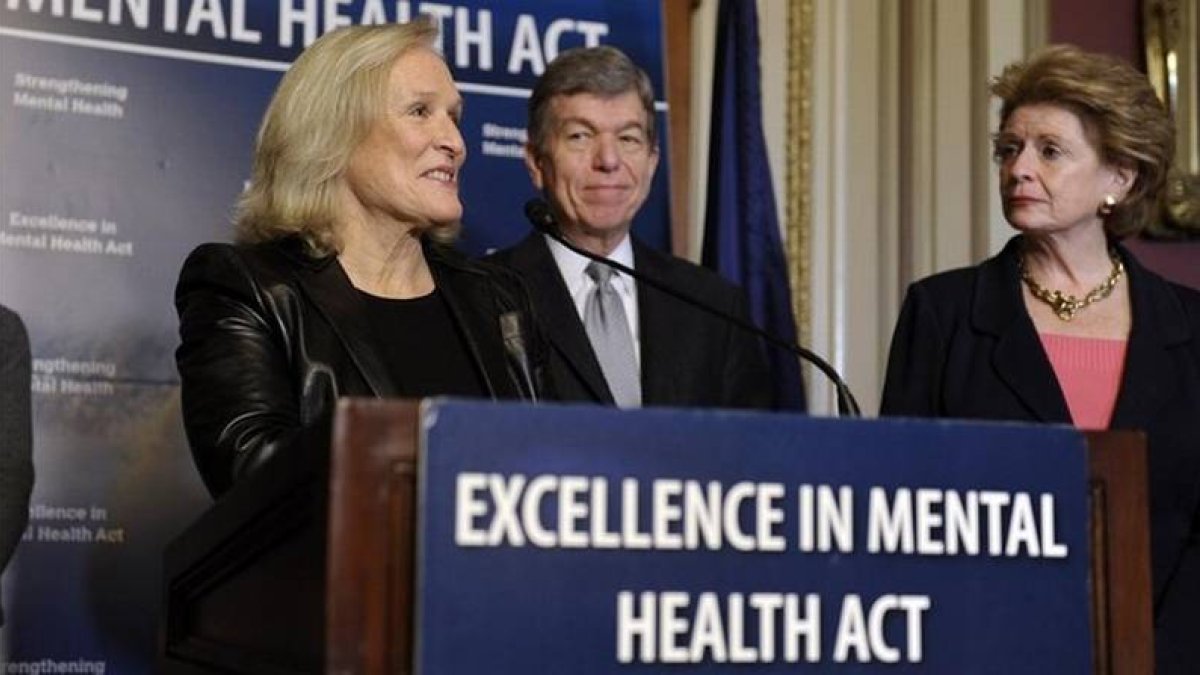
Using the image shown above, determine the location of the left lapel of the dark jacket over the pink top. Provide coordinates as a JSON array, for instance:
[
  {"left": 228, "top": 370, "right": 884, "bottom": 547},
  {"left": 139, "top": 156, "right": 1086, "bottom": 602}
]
[{"left": 971, "top": 237, "right": 1070, "bottom": 424}]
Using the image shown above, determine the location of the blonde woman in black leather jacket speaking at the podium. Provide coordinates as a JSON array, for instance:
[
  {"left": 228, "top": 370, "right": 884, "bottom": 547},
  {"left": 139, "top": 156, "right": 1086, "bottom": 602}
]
[{"left": 175, "top": 19, "right": 540, "bottom": 495}]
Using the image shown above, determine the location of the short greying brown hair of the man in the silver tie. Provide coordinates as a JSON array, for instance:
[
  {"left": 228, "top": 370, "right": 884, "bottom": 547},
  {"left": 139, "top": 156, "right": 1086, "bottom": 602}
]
[{"left": 529, "top": 46, "right": 658, "bottom": 155}]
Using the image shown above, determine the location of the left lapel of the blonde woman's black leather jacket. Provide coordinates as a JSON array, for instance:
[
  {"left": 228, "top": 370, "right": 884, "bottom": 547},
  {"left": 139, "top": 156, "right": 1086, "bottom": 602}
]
[{"left": 288, "top": 243, "right": 396, "bottom": 398}]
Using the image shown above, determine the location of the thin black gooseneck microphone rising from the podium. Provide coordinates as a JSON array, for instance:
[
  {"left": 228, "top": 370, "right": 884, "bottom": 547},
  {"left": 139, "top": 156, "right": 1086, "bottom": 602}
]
[{"left": 524, "top": 194, "right": 863, "bottom": 417}]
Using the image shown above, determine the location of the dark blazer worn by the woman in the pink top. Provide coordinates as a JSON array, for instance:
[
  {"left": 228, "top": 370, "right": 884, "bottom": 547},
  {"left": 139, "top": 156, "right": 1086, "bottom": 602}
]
[{"left": 880, "top": 237, "right": 1200, "bottom": 673}]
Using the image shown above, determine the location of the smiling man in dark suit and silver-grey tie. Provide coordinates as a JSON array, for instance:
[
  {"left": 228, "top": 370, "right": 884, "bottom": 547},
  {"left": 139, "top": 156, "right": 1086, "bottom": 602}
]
[{"left": 494, "top": 47, "right": 772, "bottom": 407}]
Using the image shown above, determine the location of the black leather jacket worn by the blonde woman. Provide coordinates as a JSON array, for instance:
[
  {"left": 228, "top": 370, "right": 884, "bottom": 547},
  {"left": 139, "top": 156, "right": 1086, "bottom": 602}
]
[{"left": 175, "top": 239, "right": 544, "bottom": 495}]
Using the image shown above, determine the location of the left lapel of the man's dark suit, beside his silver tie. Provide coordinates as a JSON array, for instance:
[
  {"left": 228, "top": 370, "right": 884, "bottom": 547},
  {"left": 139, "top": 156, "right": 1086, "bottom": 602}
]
[{"left": 511, "top": 234, "right": 613, "bottom": 402}]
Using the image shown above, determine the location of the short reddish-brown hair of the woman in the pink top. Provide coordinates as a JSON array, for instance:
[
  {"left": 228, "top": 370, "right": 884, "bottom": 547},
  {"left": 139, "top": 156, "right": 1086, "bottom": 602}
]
[{"left": 990, "top": 44, "right": 1175, "bottom": 239}]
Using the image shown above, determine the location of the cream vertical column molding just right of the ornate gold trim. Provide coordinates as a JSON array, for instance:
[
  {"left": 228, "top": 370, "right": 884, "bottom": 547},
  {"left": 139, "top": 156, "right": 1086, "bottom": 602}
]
[{"left": 810, "top": 0, "right": 899, "bottom": 413}]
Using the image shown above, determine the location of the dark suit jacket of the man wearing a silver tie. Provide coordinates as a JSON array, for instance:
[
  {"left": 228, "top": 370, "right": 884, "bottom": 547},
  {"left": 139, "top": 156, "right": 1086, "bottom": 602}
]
[{"left": 492, "top": 233, "right": 772, "bottom": 408}]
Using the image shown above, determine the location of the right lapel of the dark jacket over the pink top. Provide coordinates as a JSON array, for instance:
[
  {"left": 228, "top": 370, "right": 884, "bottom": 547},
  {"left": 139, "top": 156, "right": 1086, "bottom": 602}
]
[{"left": 1110, "top": 249, "right": 1190, "bottom": 429}]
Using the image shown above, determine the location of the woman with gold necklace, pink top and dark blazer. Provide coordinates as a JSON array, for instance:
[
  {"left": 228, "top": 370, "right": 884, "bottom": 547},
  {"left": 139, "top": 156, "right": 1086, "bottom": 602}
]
[{"left": 881, "top": 46, "right": 1200, "bottom": 673}]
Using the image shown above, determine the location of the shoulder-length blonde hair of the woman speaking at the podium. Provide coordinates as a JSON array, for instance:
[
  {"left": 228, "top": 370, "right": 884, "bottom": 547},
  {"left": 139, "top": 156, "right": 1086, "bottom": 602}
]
[{"left": 236, "top": 17, "right": 456, "bottom": 255}]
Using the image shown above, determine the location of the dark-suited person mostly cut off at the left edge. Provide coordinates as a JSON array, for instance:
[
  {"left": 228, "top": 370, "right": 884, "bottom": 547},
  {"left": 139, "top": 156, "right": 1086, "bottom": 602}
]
[{"left": 0, "top": 305, "right": 34, "bottom": 626}]
